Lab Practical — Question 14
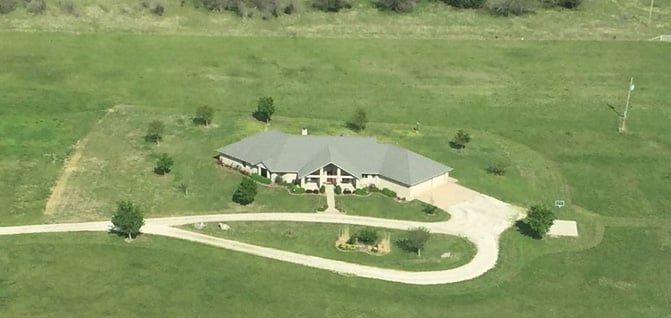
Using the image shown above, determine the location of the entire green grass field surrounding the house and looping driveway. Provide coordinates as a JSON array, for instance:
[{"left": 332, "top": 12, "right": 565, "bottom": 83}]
[{"left": 0, "top": 0, "right": 671, "bottom": 318}]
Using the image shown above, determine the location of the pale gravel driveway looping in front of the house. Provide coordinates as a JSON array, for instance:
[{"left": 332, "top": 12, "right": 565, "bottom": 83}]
[{"left": 0, "top": 183, "right": 520, "bottom": 285}]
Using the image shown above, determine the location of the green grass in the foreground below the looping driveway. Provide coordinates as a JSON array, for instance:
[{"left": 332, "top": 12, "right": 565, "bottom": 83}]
[{"left": 0, "top": 220, "right": 671, "bottom": 318}]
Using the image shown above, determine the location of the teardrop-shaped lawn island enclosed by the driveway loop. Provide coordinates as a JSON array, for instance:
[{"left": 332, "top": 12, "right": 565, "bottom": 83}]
[{"left": 182, "top": 222, "right": 475, "bottom": 271}]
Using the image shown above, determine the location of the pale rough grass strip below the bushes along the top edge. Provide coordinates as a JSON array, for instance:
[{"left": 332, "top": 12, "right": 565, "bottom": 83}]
[{"left": 0, "top": 0, "right": 671, "bottom": 41}]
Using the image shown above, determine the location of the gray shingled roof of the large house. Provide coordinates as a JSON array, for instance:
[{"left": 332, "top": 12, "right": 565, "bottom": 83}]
[{"left": 218, "top": 131, "right": 452, "bottom": 185}]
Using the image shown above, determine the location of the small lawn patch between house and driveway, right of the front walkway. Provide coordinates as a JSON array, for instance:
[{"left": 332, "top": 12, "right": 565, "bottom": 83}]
[{"left": 336, "top": 193, "right": 450, "bottom": 222}]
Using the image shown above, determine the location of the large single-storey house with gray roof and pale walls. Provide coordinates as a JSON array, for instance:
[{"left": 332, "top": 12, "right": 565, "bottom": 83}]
[{"left": 218, "top": 129, "right": 452, "bottom": 199}]
